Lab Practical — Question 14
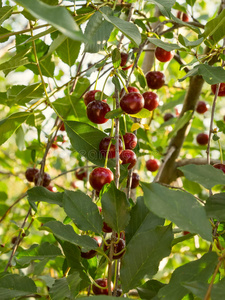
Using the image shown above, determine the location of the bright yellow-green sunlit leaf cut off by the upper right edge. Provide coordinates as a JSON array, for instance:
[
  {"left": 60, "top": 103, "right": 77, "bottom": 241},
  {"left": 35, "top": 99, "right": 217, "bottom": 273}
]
[{"left": 202, "top": 10, "right": 225, "bottom": 44}]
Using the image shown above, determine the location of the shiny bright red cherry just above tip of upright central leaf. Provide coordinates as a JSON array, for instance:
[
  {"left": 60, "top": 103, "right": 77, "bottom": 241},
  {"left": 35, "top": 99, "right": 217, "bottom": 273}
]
[{"left": 89, "top": 167, "right": 114, "bottom": 192}]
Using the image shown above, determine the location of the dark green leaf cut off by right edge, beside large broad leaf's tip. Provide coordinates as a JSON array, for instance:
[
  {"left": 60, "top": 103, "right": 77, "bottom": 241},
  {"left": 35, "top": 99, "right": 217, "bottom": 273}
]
[{"left": 205, "top": 193, "right": 225, "bottom": 222}]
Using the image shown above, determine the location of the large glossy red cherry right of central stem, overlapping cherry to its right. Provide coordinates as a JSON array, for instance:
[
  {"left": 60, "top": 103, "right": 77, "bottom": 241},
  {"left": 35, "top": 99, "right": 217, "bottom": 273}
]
[{"left": 120, "top": 93, "right": 145, "bottom": 114}]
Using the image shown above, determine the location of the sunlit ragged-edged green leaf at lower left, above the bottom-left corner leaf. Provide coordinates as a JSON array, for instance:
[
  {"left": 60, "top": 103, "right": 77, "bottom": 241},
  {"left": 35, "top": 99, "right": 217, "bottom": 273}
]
[{"left": 16, "top": 242, "right": 62, "bottom": 266}]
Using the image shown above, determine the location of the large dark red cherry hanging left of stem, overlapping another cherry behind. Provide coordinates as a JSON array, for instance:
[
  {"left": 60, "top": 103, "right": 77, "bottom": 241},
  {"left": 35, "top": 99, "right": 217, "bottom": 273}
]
[{"left": 87, "top": 100, "right": 111, "bottom": 124}]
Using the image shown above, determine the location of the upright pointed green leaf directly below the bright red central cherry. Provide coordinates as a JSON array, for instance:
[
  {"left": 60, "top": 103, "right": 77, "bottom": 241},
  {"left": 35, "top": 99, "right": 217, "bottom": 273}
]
[{"left": 102, "top": 181, "right": 130, "bottom": 232}]
